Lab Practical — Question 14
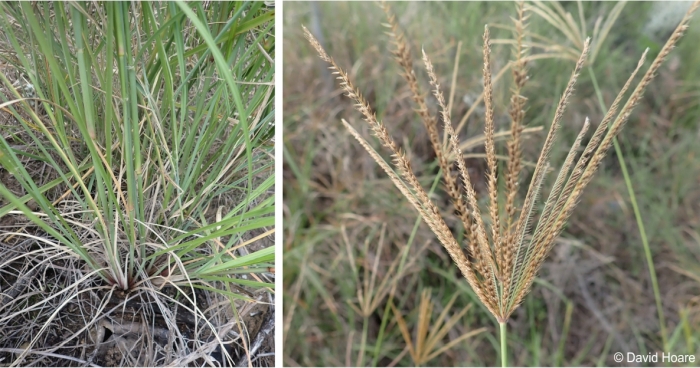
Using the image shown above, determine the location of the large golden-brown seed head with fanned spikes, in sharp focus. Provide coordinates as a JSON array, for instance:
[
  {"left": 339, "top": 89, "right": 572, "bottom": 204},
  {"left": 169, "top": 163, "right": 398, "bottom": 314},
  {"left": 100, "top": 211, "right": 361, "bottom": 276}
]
[{"left": 304, "top": 2, "right": 700, "bottom": 365}]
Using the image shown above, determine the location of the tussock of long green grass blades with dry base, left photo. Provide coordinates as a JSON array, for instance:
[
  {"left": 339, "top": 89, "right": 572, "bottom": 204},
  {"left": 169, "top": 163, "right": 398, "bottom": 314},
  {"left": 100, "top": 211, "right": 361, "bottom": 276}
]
[{"left": 0, "top": 2, "right": 274, "bottom": 364}]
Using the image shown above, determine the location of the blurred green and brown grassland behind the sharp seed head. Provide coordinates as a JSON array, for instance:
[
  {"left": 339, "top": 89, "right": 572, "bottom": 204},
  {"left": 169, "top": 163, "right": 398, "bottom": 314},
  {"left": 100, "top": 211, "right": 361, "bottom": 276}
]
[{"left": 283, "top": 2, "right": 700, "bottom": 366}]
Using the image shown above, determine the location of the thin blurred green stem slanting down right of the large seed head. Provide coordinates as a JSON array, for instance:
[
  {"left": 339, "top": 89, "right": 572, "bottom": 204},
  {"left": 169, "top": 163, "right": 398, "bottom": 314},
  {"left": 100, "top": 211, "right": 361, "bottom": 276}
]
[{"left": 588, "top": 66, "right": 669, "bottom": 351}]
